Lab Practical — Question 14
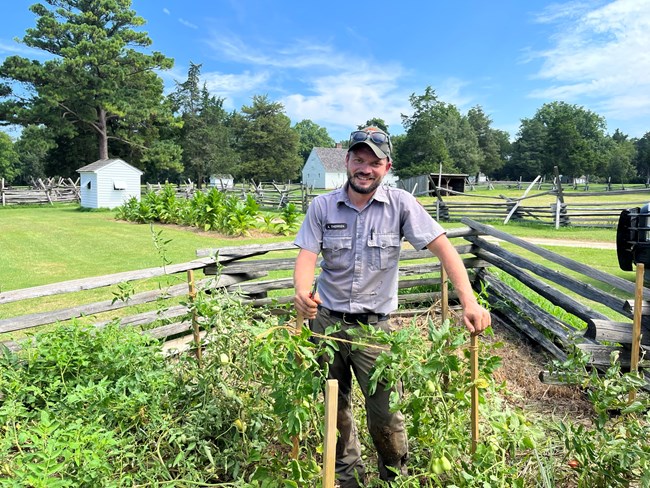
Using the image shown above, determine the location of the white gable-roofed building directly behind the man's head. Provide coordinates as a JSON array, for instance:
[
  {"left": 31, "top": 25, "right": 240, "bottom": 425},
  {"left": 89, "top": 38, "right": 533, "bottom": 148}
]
[{"left": 302, "top": 147, "right": 397, "bottom": 190}]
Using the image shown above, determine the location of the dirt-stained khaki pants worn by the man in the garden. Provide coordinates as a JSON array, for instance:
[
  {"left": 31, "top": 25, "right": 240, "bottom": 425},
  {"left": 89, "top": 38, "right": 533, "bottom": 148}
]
[{"left": 310, "top": 308, "right": 408, "bottom": 488}]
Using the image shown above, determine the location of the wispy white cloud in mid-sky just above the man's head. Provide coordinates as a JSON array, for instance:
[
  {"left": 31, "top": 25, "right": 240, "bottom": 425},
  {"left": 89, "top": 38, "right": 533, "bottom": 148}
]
[{"left": 208, "top": 36, "right": 432, "bottom": 139}]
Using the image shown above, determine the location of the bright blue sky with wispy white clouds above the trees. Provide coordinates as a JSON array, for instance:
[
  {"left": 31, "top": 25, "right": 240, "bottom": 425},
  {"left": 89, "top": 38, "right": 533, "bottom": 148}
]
[{"left": 0, "top": 0, "right": 650, "bottom": 140}]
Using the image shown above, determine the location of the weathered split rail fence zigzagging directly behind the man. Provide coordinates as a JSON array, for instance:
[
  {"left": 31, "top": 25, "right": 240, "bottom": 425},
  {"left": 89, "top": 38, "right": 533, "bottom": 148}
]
[{"left": 0, "top": 218, "right": 650, "bottom": 382}]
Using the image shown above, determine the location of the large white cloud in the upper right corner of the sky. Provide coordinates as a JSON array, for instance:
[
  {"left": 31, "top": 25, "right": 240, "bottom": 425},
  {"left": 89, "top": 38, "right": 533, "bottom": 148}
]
[{"left": 531, "top": 0, "right": 650, "bottom": 120}]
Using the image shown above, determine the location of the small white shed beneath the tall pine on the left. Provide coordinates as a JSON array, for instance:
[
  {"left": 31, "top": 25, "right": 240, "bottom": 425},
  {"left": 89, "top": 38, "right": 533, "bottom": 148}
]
[{"left": 77, "top": 159, "right": 143, "bottom": 208}]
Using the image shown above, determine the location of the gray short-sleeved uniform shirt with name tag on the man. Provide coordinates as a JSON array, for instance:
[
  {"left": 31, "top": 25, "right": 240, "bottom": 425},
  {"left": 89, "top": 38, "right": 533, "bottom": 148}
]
[{"left": 295, "top": 184, "right": 445, "bottom": 314}]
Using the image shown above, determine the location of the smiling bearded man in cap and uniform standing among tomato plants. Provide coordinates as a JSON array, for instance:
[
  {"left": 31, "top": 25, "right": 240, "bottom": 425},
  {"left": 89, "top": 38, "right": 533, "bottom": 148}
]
[{"left": 294, "top": 127, "right": 490, "bottom": 488}]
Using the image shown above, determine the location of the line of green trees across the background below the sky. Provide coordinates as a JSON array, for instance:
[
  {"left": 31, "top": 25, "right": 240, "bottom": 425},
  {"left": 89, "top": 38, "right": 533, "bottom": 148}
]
[{"left": 0, "top": 0, "right": 650, "bottom": 185}]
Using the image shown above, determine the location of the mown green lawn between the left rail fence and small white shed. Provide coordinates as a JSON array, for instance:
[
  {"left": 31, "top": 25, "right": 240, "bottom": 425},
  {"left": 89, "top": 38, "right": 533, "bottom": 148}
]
[{"left": 0, "top": 205, "right": 290, "bottom": 291}]
